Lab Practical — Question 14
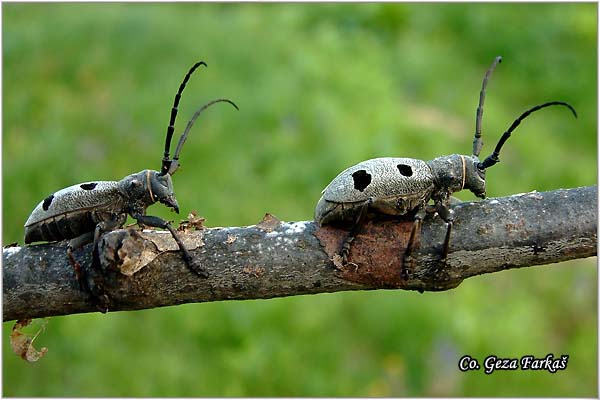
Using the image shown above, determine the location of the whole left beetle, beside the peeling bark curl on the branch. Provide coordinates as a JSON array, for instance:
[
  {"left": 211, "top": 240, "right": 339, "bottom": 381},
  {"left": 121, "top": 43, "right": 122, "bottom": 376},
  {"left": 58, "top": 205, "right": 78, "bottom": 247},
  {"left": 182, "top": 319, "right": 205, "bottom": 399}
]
[{"left": 25, "top": 61, "right": 238, "bottom": 289}]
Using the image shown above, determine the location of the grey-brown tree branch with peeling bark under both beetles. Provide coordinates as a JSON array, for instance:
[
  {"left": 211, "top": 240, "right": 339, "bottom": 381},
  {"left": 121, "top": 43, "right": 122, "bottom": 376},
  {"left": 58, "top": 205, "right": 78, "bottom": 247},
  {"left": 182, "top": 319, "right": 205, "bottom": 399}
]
[{"left": 3, "top": 186, "right": 598, "bottom": 321}]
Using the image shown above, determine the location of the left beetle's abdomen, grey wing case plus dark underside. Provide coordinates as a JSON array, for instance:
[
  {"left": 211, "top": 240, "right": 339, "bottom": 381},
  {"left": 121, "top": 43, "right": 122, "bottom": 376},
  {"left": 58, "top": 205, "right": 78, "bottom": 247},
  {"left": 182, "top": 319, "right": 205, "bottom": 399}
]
[{"left": 25, "top": 181, "right": 125, "bottom": 243}]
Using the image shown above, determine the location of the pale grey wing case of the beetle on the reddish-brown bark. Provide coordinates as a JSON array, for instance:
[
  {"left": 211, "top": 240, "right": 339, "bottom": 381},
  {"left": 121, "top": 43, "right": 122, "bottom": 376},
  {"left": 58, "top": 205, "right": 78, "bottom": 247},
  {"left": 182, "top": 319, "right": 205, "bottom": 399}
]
[{"left": 323, "top": 157, "right": 433, "bottom": 203}]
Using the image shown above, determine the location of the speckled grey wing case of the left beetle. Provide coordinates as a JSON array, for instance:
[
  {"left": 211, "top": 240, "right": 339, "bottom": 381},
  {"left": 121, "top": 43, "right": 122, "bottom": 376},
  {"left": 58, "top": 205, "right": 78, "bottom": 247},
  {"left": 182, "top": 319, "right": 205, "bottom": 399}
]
[{"left": 25, "top": 181, "right": 122, "bottom": 226}]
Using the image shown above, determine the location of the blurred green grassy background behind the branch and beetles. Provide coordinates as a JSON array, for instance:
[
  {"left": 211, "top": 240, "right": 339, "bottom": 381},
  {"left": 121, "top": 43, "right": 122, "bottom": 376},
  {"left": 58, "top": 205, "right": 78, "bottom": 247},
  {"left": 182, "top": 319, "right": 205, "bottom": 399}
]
[{"left": 2, "top": 3, "right": 598, "bottom": 397}]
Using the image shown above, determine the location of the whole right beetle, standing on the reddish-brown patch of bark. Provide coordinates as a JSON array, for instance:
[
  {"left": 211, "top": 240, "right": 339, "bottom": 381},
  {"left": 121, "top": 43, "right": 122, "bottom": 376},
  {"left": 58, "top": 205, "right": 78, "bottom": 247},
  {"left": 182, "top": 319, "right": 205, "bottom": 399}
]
[{"left": 315, "top": 56, "right": 577, "bottom": 279}]
